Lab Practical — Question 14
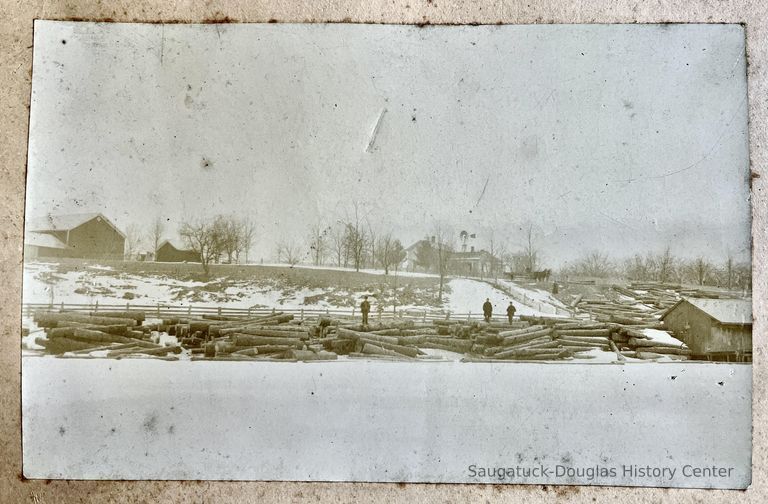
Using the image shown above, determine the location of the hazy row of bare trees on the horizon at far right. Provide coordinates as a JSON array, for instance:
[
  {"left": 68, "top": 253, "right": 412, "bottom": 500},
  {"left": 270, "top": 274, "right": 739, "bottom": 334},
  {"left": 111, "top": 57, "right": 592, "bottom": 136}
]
[{"left": 560, "top": 247, "right": 752, "bottom": 289}]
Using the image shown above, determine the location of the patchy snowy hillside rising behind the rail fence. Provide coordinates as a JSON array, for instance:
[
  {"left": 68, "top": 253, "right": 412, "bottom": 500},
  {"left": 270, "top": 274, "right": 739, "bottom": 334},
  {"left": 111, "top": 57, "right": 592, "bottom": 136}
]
[{"left": 23, "top": 262, "right": 552, "bottom": 316}]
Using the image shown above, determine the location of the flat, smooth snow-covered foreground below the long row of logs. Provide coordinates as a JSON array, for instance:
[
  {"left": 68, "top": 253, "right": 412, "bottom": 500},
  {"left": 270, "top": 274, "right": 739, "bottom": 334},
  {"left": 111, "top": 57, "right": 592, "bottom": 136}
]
[{"left": 22, "top": 357, "right": 752, "bottom": 488}]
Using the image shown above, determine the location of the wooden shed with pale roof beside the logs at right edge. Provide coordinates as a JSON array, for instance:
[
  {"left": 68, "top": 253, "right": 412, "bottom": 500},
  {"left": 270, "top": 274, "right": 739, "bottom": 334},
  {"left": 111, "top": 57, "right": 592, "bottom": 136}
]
[{"left": 661, "top": 298, "right": 752, "bottom": 362}]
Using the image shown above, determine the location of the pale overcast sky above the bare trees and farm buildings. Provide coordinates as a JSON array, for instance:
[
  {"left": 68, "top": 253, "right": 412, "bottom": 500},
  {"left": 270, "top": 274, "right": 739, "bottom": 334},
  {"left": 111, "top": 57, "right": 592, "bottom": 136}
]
[{"left": 27, "top": 22, "right": 750, "bottom": 264}]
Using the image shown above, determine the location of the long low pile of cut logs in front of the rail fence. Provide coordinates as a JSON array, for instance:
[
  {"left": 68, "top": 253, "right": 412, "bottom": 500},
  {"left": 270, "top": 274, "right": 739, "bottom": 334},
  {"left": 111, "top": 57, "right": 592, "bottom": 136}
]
[{"left": 34, "top": 312, "right": 690, "bottom": 362}]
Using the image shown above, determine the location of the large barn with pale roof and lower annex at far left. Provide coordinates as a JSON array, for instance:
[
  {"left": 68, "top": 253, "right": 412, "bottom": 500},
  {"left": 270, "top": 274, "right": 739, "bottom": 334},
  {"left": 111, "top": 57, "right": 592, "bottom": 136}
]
[{"left": 24, "top": 213, "right": 125, "bottom": 259}]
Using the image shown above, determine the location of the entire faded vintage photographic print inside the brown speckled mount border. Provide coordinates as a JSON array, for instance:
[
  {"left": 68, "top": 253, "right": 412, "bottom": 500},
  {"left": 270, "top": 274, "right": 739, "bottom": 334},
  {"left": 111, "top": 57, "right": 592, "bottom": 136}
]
[{"left": 21, "top": 21, "right": 752, "bottom": 488}]
